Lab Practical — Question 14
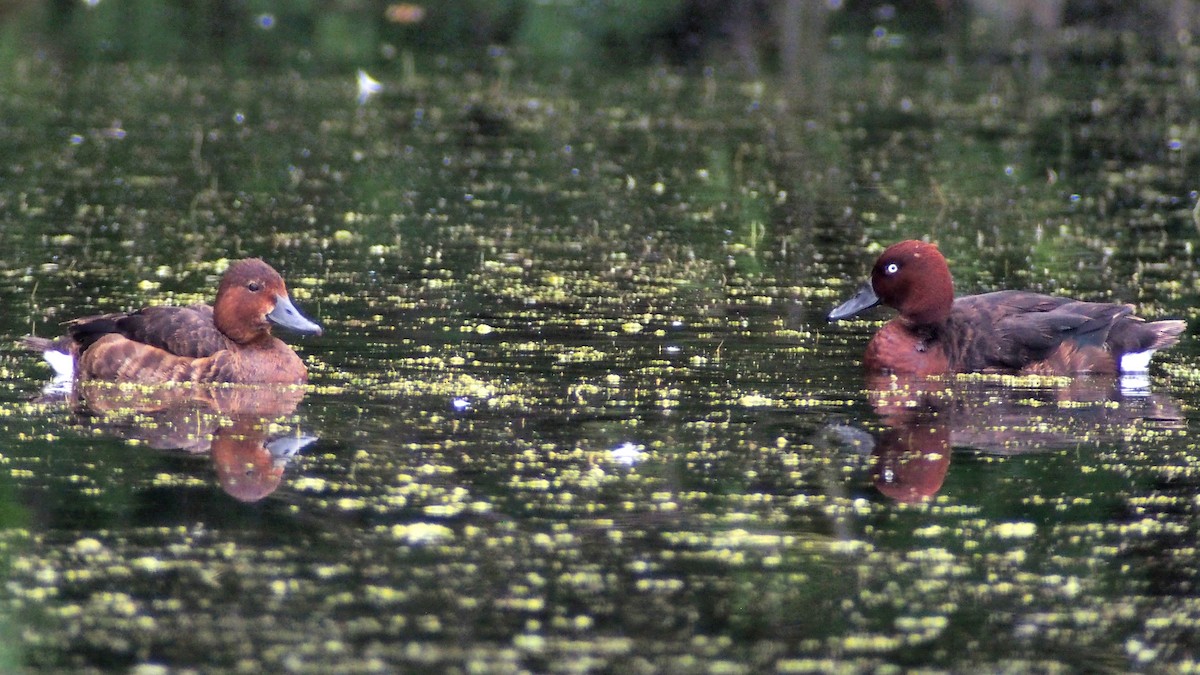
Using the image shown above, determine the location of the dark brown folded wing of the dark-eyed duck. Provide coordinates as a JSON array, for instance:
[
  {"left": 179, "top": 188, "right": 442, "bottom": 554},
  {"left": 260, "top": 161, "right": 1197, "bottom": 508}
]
[{"left": 67, "top": 304, "right": 233, "bottom": 358}]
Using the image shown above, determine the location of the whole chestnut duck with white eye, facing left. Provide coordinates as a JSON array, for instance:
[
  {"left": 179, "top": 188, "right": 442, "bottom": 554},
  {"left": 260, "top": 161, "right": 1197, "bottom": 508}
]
[{"left": 829, "top": 241, "right": 1186, "bottom": 376}]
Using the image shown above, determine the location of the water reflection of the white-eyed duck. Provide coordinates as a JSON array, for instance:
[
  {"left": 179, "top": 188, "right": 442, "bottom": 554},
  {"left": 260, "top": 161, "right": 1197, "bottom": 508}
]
[{"left": 836, "top": 376, "right": 1186, "bottom": 502}]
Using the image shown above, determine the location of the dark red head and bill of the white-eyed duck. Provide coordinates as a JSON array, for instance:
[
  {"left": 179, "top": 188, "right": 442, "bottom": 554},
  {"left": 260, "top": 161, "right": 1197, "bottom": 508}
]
[{"left": 829, "top": 239, "right": 954, "bottom": 325}]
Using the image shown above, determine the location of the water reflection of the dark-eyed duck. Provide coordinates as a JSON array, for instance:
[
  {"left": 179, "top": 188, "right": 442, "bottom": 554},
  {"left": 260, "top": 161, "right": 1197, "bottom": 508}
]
[{"left": 58, "top": 382, "right": 317, "bottom": 502}]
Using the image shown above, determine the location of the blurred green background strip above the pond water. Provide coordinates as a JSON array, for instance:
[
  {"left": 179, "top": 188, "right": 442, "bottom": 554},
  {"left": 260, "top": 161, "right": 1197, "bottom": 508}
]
[{"left": 0, "top": 0, "right": 1196, "bottom": 73}]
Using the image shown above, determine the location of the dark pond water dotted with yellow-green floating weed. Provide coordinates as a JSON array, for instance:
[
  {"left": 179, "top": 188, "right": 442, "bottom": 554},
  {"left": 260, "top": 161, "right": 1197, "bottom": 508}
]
[{"left": 0, "top": 55, "right": 1200, "bottom": 673}]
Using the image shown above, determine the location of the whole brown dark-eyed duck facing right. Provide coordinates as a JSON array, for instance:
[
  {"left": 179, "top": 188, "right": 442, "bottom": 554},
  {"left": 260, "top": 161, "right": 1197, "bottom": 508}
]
[{"left": 25, "top": 258, "right": 320, "bottom": 384}]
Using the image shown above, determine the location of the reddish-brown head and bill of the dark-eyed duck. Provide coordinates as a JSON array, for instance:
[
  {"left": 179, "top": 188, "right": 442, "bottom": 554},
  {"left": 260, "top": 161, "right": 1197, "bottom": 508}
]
[{"left": 212, "top": 258, "right": 320, "bottom": 345}]
